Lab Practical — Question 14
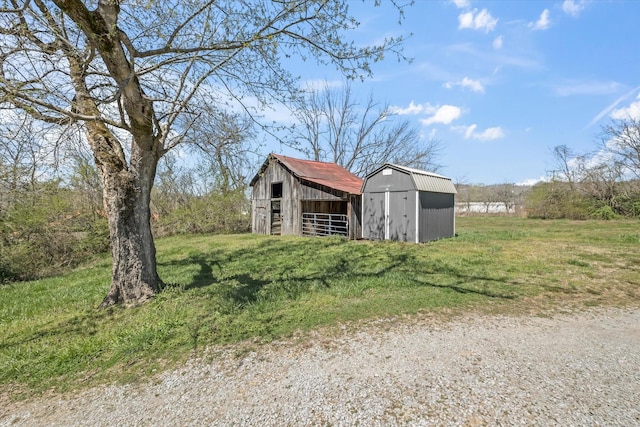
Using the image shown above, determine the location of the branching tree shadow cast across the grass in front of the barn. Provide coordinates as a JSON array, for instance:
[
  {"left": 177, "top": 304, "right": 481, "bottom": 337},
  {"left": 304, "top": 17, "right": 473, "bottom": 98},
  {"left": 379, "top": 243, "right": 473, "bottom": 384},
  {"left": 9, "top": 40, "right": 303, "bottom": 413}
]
[{"left": 162, "top": 238, "right": 518, "bottom": 307}]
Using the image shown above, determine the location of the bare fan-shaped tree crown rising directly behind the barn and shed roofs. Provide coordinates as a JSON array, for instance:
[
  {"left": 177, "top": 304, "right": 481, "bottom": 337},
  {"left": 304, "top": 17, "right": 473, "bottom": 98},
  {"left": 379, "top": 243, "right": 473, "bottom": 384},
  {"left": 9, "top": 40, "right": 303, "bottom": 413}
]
[{"left": 294, "top": 82, "right": 440, "bottom": 176}]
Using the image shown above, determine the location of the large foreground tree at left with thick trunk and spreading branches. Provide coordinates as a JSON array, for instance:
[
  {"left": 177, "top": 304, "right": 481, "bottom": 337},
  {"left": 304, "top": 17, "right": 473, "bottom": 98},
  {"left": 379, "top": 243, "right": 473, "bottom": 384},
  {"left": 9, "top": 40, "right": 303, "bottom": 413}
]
[{"left": 0, "top": 0, "right": 408, "bottom": 306}]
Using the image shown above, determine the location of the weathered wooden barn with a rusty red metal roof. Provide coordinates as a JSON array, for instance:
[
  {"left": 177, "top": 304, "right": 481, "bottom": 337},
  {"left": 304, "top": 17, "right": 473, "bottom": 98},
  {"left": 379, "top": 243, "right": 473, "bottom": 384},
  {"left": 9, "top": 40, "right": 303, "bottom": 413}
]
[{"left": 251, "top": 153, "right": 362, "bottom": 239}]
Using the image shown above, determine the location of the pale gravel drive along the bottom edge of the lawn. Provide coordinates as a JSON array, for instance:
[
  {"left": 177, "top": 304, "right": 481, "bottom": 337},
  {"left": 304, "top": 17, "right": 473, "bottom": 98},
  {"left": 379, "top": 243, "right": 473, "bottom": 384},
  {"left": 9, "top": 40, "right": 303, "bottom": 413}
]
[{"left": 0, "top": 309, "right": 640, "bottom": 426}]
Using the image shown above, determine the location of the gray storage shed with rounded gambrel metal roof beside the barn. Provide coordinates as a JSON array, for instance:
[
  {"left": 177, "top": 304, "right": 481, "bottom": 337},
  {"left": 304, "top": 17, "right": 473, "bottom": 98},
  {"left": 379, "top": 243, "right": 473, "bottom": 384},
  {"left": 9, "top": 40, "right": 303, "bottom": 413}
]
[{"left": 362, "top": 163, "right": 456, "bottom": 243}]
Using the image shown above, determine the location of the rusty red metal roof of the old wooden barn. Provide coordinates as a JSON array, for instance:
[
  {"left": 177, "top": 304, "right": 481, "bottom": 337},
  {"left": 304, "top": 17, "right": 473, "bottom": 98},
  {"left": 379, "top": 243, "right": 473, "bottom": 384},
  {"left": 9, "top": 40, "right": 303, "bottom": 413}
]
[{"left": 251, "top": 153, "right": 362, "bottom": 194}]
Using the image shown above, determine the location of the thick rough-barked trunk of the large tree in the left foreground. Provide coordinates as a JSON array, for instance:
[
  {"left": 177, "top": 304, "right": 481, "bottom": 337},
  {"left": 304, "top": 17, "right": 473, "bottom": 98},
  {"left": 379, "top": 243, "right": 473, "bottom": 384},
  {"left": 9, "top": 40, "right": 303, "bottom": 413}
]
[{"left": 100, "top": 147, "right": 162, "bottom": 307}]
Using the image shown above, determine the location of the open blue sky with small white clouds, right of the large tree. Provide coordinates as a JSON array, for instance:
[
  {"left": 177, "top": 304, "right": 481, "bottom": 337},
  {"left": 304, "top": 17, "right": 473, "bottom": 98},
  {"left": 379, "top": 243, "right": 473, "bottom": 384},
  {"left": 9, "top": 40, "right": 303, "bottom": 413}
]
[{"left": 268, "top": 0, "right": 640, "bottom": 185}]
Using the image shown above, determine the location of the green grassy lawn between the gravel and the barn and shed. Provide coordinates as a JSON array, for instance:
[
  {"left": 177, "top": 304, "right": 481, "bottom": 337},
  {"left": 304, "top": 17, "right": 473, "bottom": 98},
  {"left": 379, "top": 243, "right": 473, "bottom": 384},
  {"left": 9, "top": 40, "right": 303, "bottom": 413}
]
[{"left": 0, "top": 217, "right": 640, "bottom": 397}]
